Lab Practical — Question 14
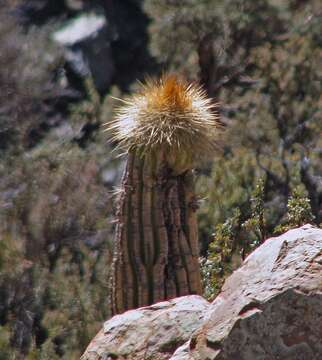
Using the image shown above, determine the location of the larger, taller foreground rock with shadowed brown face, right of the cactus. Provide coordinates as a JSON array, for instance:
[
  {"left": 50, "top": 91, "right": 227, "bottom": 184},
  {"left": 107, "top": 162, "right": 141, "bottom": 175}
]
[{"left": 171, "top": 225, "right": 322, "bottom": 360}]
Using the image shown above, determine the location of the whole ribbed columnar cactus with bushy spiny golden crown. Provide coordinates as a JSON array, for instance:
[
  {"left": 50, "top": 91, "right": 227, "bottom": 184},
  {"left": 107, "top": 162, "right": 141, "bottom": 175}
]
[{"left": 108, "top": 76, "right": 219, "bottom": 314}]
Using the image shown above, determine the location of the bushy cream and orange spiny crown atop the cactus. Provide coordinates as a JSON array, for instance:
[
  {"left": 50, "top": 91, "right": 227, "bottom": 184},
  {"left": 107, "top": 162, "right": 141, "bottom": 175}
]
[{"left": 107, "top": 75, "right": 220, "bottom": 173}]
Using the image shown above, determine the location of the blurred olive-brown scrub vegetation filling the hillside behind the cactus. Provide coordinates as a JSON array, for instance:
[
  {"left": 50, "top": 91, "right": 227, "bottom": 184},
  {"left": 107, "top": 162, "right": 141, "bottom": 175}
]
[{"left": 0, "top": 0, "right": 322, "bottom": 359}]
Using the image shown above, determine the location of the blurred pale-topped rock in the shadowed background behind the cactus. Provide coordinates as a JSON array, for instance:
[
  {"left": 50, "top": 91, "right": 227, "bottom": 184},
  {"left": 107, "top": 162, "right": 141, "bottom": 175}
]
[{"left": 52, "top": 12, "right": 115, "bottom": 92}]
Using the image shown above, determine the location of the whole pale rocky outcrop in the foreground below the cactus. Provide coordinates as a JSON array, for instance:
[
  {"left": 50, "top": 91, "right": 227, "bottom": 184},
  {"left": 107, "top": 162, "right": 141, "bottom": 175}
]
[{"left": 82, "top": 225, "right": 322, "bottom": 360}]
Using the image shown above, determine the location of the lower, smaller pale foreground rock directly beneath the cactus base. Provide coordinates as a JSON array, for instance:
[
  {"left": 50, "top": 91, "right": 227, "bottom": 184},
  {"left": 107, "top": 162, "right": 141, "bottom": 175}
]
[{"left": 81, "top": 295, "right": 210, "bottom": 360}]
